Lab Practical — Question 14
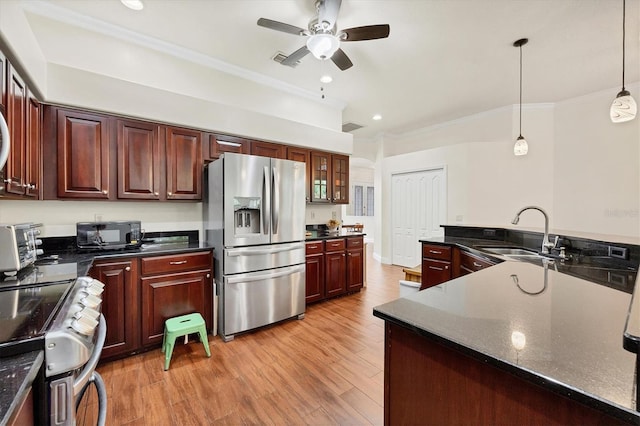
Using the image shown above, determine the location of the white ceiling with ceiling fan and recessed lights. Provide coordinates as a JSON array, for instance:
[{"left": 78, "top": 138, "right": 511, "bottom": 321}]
[{"left": 12, "top": 0, "right": 640, "bottom": 139}]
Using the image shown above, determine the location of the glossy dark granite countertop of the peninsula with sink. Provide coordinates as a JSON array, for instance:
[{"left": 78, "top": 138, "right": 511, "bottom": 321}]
[{"left": 374, "top": 243, "right": 640, "bottom": 423}]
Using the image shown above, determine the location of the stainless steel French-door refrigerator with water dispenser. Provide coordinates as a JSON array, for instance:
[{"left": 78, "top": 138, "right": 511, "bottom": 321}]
[{"left": 203, "top": 153, "right": 306, "bottom": 341}]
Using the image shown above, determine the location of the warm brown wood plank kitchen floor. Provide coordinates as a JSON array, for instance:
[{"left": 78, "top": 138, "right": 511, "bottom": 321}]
[{"left": 78, "top": 247, "right": 404, "bottom": 425}]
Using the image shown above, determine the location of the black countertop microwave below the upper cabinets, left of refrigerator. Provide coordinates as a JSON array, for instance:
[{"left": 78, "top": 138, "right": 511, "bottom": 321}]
[{"left": 76, "top": 220, "right": 143, "bottom": 250}]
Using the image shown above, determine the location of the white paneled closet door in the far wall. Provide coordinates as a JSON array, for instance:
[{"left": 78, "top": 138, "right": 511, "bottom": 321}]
[{"left": 391, "top": 169, "right": 446, "bottom": 268}]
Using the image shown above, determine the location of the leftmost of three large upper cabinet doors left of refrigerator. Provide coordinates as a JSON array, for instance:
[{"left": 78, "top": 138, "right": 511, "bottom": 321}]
[{"left": 57, "top": 109, "right": 111, "bottom": 199}]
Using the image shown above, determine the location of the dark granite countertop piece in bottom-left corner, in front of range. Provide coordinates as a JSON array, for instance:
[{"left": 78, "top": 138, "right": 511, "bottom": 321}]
[{"left": 0, "top": 351, "right": 44, "bottom": 425}]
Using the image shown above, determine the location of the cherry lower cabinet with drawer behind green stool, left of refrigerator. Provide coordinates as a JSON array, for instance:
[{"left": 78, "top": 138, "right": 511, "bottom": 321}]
[{"left": 89, "top": 251, "right": 213, "bottom": 360}]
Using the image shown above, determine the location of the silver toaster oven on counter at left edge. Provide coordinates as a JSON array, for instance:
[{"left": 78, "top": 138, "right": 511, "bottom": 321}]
[{"left": 0, "top": 223, "right": 42, "bottom": 275}]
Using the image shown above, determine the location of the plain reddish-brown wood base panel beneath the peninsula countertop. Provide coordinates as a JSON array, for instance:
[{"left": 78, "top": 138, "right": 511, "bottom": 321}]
[{"left": 384, "top": 322, "right": 624, "bottom": 426}]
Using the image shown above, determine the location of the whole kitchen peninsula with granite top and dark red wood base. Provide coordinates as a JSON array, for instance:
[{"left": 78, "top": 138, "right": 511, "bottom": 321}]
[{"left": 374, "top": 229, "right": 640, "bottom": 425}]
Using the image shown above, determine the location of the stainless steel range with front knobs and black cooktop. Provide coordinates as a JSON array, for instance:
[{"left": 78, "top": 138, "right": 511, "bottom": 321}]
[{"left": 0, "top": 263, "right": 106, "bottom": 425}]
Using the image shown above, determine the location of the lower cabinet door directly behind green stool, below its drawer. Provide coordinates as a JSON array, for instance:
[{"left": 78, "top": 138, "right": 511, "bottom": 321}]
[{"left": 140, "top": 271, "right": 213, "bottom": 346}]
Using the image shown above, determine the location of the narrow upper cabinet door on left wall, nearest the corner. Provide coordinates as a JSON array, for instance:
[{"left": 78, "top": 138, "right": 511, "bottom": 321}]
[{"left": 25, "top": 96, "right": 42, "bottom": 198}]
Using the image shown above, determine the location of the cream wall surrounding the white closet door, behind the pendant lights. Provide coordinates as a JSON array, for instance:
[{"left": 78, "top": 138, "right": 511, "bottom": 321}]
[{"left": 370, "top": 83, "right": 640, "bottom": 262}]
